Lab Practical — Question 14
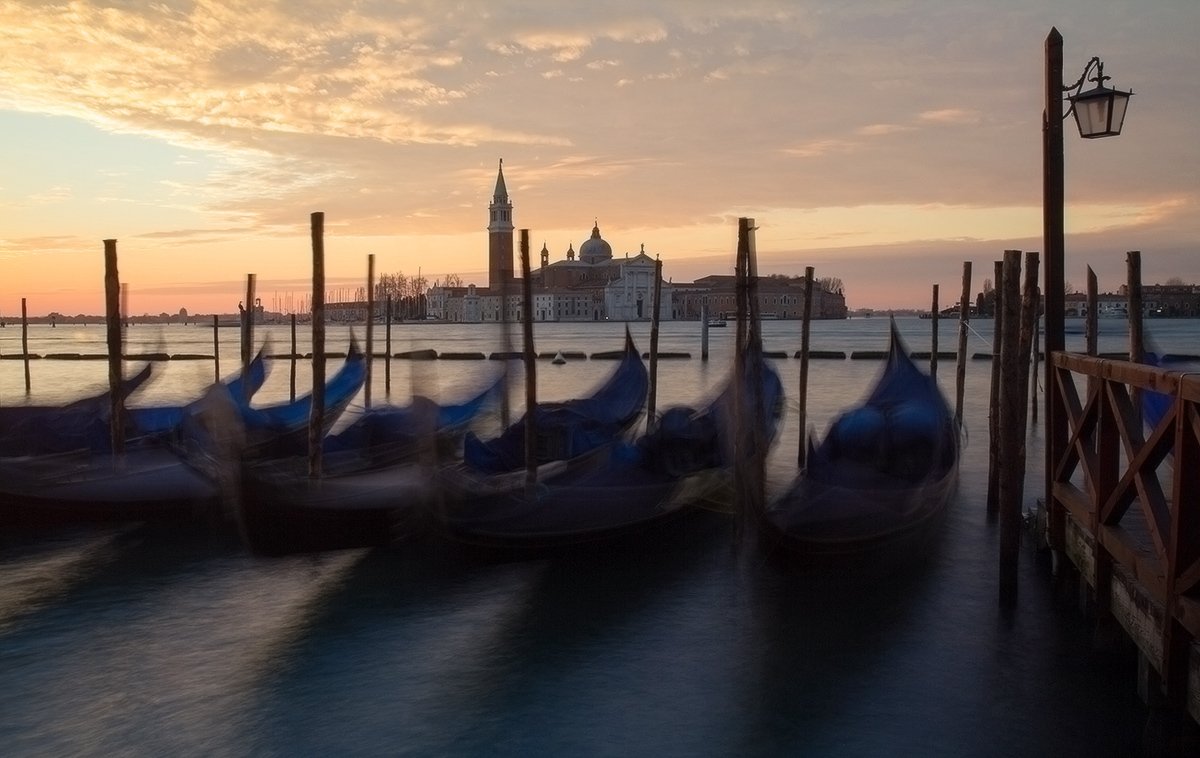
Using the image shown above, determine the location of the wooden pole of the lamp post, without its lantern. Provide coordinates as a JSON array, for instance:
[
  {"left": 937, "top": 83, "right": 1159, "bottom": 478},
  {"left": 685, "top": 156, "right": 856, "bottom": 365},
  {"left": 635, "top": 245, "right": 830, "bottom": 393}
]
[{"left": 1042, "top": 28, "right": 1067, "bottom": 551}]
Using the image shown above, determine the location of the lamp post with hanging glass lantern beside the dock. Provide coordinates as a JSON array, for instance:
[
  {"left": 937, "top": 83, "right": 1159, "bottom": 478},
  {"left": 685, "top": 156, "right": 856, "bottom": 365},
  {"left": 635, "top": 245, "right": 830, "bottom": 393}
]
[{"left": 1042, "top": 28, "right": 1133, "bottom": 551}]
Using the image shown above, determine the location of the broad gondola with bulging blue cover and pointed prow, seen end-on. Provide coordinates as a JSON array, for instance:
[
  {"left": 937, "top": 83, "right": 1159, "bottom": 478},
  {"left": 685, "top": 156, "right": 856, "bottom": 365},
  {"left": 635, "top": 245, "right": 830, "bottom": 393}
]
[{"left": 763, "top": 321, "right": 959, "bottom": 564}]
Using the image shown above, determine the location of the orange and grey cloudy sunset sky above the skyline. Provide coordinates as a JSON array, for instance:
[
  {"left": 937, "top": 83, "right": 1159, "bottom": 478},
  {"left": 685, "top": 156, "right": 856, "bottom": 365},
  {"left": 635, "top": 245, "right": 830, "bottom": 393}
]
[{"left": 0, "top": 0, "right": 1200, "bottom": 318}]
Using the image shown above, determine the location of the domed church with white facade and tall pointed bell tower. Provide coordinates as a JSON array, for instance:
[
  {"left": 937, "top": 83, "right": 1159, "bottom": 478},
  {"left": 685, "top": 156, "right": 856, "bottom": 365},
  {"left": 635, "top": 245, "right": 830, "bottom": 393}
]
[{"left": 427, "top": 161, "right": 673, "bottom": 323}]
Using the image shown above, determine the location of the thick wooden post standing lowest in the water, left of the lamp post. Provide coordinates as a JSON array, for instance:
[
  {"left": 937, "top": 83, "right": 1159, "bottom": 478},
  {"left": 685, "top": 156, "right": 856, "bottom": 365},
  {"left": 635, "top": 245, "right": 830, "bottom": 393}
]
[{"left": 998, "top": 249, "right": 1025, "bottom": 608}]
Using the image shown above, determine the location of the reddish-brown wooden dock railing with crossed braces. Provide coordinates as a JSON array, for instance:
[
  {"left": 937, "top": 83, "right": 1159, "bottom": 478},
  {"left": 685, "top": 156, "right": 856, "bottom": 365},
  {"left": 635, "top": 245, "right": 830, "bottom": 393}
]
[{"left": 1046, "top": 353, "right": 1200, "bottom": 721}]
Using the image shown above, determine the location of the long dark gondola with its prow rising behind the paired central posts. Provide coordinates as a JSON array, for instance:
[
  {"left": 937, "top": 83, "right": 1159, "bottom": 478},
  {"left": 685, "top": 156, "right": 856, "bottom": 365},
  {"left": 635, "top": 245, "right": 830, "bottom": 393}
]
[{"left": 443, "top": 335, "right": 782, "bottom": 555}]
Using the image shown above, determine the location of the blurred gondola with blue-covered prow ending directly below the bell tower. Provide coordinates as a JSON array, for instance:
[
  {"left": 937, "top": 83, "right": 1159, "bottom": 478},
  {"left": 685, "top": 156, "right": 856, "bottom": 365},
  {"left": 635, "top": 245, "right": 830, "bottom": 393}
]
[{"left": 238, "top": 383, "right": 500, "bottom": 555}]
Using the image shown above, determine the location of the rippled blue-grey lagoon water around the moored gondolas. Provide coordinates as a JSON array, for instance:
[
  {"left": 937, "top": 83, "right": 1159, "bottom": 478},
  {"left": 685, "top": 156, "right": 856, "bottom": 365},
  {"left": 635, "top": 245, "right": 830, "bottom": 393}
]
[{"left": 0, "top": 319, "right": 1200, "bottom": 756}]
